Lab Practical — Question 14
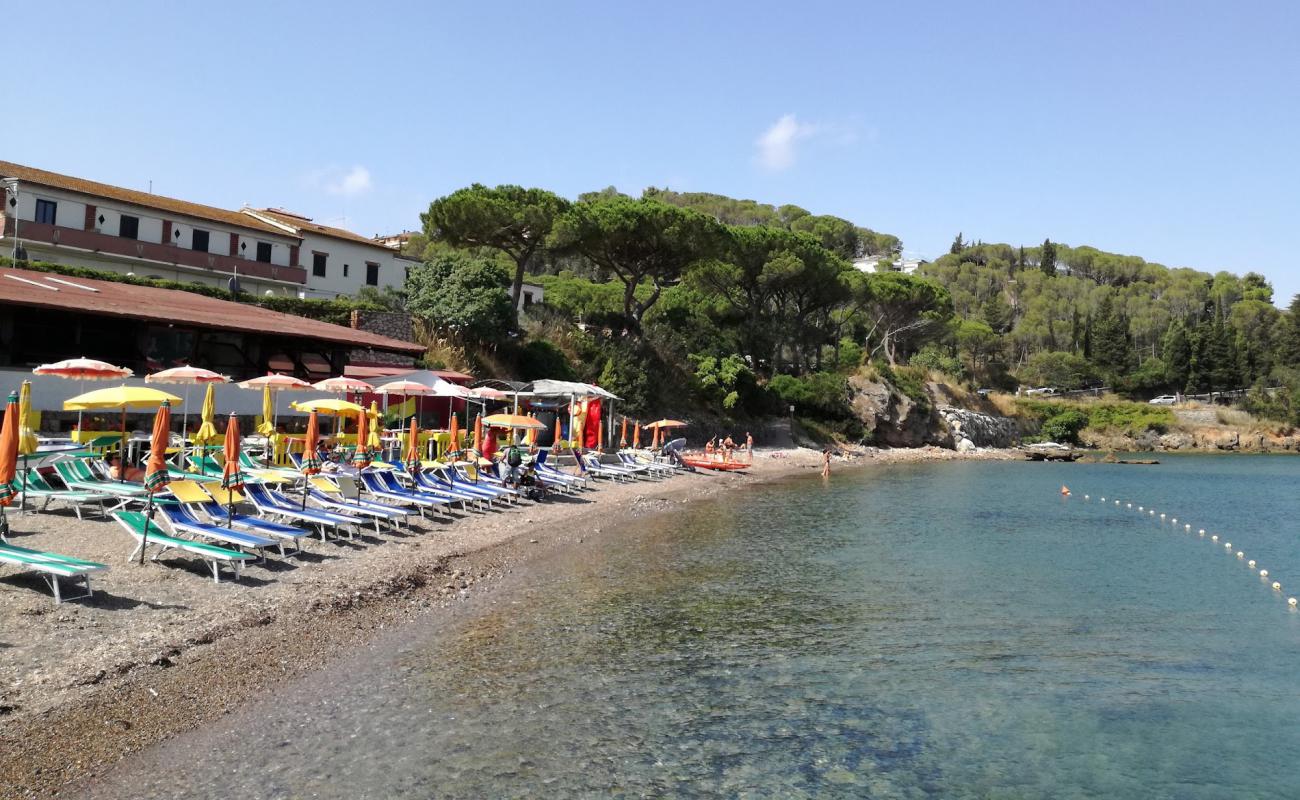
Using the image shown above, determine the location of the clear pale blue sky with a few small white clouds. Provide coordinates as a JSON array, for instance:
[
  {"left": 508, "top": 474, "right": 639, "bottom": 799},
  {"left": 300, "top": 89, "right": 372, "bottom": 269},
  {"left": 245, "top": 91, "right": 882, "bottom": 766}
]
[{"left": 10, "top": 0, "right": 1300, "bottom": 304}]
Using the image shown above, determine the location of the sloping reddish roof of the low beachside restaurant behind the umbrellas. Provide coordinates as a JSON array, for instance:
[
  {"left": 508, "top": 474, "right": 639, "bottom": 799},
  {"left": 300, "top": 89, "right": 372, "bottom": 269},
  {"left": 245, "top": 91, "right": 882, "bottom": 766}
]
[{"left": 0, "top": 268, "right": 424, "bottom": 354}]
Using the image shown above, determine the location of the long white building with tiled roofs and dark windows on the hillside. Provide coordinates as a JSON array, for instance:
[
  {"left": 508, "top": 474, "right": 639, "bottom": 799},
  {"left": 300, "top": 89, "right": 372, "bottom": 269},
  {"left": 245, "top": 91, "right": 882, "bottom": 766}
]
[{"left": 0, "top": 161, "right": 410, "bottom": 298}]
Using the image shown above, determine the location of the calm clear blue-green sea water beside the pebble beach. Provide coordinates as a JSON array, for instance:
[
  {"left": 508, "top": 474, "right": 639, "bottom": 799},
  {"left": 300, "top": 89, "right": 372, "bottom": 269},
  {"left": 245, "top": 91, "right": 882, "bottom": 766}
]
[{"left": 83, "top": 457, "right": 1300, "bottom": 799}]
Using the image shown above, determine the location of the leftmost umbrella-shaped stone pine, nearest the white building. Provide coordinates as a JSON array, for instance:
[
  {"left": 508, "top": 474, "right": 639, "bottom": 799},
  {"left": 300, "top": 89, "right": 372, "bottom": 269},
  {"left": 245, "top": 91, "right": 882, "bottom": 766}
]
[{"left": 420, "top": 183, "right": 569, "bottom": 323}]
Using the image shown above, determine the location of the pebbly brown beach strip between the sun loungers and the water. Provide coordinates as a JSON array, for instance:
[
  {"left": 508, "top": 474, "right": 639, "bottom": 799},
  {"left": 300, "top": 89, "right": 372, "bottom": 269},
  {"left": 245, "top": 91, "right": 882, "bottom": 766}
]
[{"left": 0, "top": 447, "right": 1017, "bottom": 797}]
